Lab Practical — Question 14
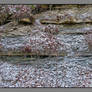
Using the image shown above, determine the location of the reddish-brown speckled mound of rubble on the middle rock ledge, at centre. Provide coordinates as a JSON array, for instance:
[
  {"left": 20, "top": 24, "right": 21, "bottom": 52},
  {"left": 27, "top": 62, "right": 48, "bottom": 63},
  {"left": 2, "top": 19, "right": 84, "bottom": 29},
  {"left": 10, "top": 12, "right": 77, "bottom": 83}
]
[{"left": 24, "top": 30, "right": 65, "bottom": 55}]
